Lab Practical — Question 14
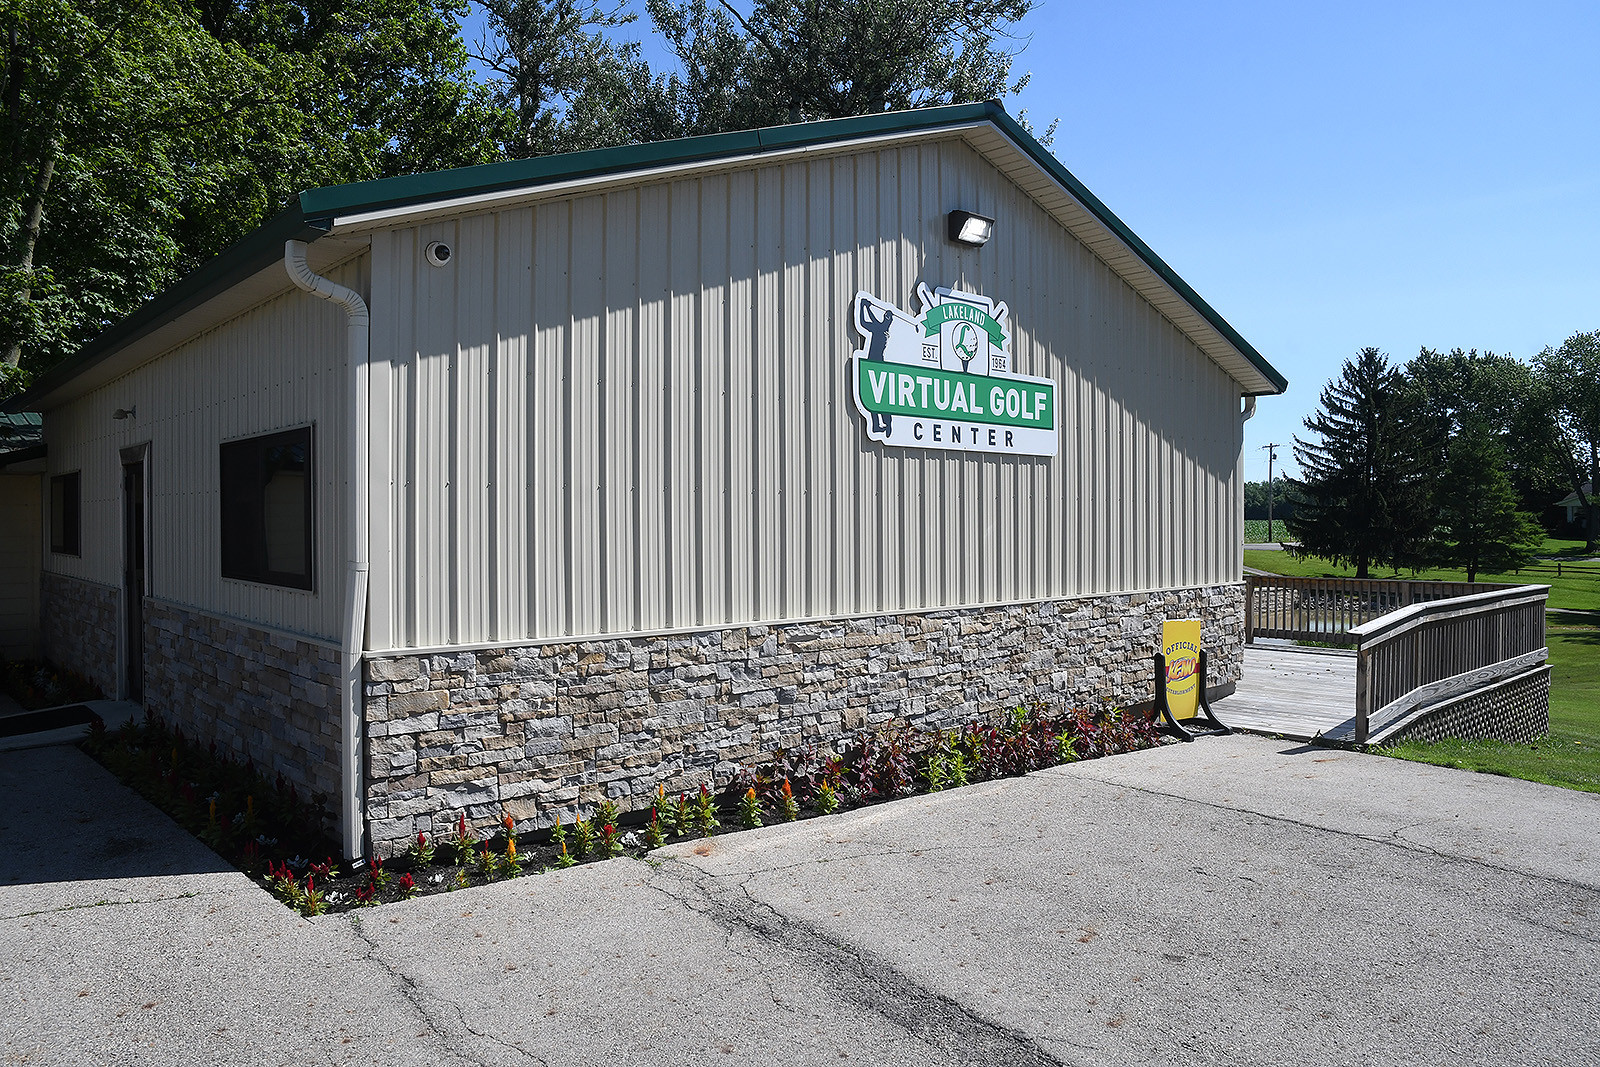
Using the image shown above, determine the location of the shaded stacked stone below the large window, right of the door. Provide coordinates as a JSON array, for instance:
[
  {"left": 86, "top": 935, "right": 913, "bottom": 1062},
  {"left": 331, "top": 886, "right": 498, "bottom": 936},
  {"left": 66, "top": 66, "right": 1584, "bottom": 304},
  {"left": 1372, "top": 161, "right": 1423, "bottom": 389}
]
[{"left": 144, "top": 600, "right": 341, "bottom": 803}]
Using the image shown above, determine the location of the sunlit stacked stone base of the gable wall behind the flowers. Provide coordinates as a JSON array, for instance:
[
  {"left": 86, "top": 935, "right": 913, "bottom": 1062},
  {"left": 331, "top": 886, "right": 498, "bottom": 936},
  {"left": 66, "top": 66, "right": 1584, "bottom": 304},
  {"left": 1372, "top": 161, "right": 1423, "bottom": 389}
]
[{"left": 365, "top": 584, "right": 1243, "bottom": 854}]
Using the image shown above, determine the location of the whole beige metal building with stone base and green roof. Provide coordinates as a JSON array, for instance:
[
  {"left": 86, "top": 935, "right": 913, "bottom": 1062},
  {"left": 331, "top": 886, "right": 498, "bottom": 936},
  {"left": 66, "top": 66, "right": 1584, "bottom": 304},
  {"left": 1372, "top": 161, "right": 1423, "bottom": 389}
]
[{"left": 8, "top": 104, "right": 1285, "bottom": 854}]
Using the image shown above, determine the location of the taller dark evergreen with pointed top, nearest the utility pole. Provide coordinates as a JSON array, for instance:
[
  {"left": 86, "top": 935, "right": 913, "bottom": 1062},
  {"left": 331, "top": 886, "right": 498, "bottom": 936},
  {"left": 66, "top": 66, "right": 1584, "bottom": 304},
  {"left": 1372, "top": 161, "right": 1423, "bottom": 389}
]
[{"left": 1285, "top": 349, "right": 1434, "bottom": 577}]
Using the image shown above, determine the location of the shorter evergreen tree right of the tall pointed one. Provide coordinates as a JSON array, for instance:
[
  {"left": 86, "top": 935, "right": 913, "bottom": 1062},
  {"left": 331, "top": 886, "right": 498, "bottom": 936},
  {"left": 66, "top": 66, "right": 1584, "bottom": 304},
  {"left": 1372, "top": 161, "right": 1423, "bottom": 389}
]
[{"left": 1437, "top": 424, "right": 1544, "bottom": 582}]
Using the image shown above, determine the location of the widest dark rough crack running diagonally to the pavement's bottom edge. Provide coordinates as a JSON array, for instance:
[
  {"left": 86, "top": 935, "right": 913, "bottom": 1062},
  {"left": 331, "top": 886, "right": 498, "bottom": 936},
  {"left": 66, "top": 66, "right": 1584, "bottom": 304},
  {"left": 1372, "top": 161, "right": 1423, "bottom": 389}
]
[{"left": 645, "top": 859, "right": 1064, "bottom": 1067}]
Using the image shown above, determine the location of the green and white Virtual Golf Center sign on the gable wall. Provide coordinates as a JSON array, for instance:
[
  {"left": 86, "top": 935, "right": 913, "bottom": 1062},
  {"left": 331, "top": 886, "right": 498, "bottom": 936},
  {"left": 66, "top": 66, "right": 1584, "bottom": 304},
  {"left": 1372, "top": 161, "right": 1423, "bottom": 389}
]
[{"left": 850, "top": 285, "right": 1056, "bottom": 456}]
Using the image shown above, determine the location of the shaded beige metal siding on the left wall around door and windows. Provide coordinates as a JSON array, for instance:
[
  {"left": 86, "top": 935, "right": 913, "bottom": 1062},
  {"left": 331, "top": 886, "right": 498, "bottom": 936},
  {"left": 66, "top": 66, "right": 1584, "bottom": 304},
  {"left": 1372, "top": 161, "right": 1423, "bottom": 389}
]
[{"left": 45, "top": 258, "right": 366, "bottom": 640}]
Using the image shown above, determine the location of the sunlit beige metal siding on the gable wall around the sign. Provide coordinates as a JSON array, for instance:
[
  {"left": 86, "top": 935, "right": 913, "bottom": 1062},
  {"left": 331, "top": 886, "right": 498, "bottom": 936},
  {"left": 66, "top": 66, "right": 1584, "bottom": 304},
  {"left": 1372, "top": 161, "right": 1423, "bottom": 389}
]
[{"left": 368, "top": 139, "right": 1242, "bottom": 648}]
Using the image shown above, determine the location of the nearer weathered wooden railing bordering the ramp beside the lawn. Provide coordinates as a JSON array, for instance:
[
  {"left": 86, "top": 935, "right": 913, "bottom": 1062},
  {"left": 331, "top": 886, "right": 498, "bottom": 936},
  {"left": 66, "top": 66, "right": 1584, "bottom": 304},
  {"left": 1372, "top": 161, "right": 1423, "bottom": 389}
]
[{"left": 1349, "top": 585, "right": 1550, "bottom": 744}]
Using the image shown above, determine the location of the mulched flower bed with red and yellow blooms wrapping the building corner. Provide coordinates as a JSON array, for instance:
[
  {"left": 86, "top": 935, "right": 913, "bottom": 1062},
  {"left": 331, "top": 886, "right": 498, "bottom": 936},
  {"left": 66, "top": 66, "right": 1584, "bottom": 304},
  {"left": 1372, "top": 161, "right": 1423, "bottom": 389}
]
[{"left": 85, "top": 704, "right": 1163, "bottom": 915}]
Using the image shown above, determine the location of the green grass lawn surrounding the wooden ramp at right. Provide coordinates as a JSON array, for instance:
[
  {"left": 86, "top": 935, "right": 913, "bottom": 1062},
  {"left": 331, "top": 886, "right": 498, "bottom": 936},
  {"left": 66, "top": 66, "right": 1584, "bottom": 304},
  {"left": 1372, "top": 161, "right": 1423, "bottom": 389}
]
[{"left": 1245, "top": 542, "right": 1600, "bottom": 792}]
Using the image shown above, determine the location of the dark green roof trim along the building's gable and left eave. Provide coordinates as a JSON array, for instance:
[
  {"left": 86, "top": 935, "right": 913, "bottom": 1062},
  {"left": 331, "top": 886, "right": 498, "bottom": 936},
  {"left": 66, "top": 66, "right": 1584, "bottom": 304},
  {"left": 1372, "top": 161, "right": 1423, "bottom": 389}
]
[{"left": 0, "top": 101, "right": 1288, "bottom": 411}]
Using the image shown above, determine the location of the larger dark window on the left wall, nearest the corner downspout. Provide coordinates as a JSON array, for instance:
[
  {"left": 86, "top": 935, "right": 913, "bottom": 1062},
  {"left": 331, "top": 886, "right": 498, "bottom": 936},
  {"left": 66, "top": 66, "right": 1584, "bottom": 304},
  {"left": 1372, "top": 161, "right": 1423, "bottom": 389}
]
[{"left": 221, "top": 427, "right": 312, "bottom": 589}]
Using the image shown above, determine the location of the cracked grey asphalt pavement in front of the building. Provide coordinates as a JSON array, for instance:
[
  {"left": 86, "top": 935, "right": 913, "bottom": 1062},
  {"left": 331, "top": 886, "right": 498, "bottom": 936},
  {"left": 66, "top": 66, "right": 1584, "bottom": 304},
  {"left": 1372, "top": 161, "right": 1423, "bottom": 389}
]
[{"left": 0, "top": 737, "right": 1600, "bottom": 1067}]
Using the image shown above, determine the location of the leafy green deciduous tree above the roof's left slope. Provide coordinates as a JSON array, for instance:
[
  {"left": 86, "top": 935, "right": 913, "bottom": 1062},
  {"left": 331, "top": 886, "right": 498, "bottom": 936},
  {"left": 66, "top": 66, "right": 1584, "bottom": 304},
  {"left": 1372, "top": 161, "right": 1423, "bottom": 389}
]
[{"left": 0, "top": 0, "right": 501, "bottom": 392}]
